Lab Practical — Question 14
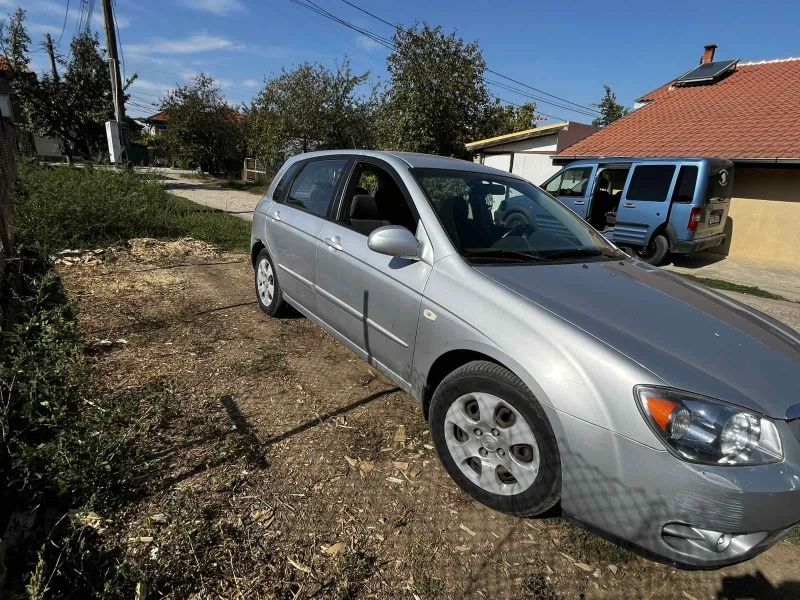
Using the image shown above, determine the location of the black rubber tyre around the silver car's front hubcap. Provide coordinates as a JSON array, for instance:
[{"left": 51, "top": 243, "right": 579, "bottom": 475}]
[{"left": 429, "top": 360, "right": 561, "bottom": 517}]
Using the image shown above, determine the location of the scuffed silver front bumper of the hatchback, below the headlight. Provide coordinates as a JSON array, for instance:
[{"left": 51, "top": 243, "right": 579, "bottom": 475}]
[{"left": 546, "top": 408, "right": 800, "bottom": 569}]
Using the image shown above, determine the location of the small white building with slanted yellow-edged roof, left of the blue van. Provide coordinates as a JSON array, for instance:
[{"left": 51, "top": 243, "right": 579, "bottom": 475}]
[{"left": 466, "top": 121, "right": 597, "bottom": 185}]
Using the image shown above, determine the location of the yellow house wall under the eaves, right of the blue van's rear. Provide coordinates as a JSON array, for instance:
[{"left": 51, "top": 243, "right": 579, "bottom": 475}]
[{"left": 714, "top": 168, "right": 800, "bottom": 266}]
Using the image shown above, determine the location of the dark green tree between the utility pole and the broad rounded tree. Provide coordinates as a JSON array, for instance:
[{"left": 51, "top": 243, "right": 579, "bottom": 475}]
[{"left": 161, "top": 73, "right": 244, "bottom": 175}]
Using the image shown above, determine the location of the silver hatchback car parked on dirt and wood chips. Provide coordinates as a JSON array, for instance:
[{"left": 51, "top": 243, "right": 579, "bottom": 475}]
[{"left": 251, "top": 150, "right": 800, "bottom": 568}]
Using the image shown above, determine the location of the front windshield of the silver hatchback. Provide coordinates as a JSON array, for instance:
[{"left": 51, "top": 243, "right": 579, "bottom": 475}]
[{"left": 412, "top": 169, "right": 617, "bottom": 263}]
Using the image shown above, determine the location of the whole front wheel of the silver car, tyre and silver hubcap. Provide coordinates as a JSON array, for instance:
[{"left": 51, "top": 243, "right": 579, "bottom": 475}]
[{"left": 429, "top": 360, "right": 561, "bottom": 517}]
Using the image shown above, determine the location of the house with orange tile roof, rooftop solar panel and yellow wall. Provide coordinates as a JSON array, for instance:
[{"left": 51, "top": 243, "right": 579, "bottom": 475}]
[{"left": 554, "top": 46, "right": 800, "bottom": 265}]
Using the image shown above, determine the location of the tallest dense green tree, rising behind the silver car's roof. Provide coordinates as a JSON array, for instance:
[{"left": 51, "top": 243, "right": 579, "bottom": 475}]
[{"left": 381, "top": 23, "right": 492, "bottom": 156}]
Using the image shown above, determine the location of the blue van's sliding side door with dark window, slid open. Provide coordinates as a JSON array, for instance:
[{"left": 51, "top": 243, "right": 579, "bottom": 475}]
[{"left": 613, "top": 160, "right": 678, "bottom": 246}]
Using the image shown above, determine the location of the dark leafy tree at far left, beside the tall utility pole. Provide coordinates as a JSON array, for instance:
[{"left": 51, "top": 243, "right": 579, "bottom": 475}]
[{"left": 1, "top": 9, "right": 130, "bottom": 159}]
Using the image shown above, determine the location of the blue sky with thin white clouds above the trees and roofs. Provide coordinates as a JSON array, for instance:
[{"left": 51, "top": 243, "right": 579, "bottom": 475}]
[{"left": 9, "top": 0, "right": 800, "bottom": 122}]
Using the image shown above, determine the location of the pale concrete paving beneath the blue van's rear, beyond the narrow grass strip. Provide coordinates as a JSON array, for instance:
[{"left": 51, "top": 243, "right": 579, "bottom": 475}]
[{"left": 663, "top": 252, "right": 800, "bottom": 302}]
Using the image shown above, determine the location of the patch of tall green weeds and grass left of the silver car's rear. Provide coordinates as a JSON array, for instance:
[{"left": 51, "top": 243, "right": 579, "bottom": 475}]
[{"left": 14, "top": 161, "right": 250, "bottom": 254}]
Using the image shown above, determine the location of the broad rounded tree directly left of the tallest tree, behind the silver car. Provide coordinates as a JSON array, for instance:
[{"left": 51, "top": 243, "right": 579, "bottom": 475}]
[{"left": 245, "top": 57, "right": 377, "bottom": 169}]
